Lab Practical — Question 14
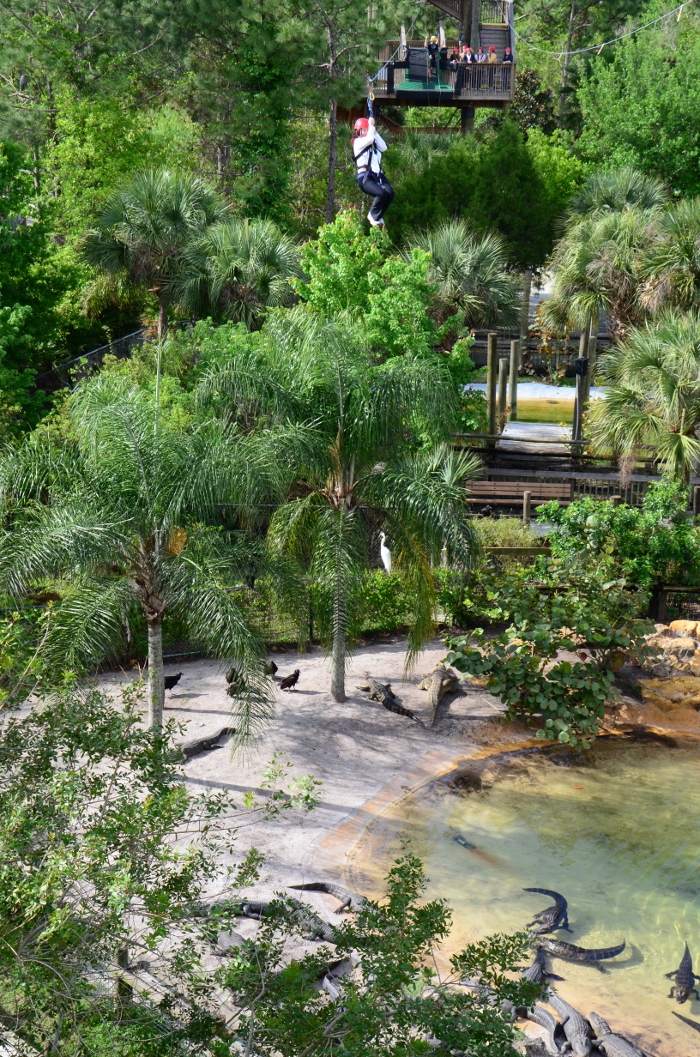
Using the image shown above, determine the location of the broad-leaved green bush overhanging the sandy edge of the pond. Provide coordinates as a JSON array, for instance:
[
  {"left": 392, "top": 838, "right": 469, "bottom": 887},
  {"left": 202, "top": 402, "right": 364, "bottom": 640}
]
[{"left": 448, "top": 559, "right": 653, "bottom": 748}]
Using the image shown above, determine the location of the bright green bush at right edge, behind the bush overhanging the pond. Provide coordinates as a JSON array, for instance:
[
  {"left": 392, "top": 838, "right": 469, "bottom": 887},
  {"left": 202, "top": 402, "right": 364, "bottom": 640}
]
[{"left": 538, "top": 480, "right": 700, "bottom": 589}]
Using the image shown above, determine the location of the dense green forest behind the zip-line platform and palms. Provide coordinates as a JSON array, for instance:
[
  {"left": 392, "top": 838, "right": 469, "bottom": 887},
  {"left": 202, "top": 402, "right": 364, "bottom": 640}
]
[{"left": 0, "top": 0, "right": 700, "bottom": 428}]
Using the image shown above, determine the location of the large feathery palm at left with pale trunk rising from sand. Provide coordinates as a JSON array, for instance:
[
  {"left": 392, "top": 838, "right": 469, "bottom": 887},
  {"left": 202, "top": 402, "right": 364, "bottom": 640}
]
[{"left": 0, "top": 375, "right": 294, "bottom": 737}]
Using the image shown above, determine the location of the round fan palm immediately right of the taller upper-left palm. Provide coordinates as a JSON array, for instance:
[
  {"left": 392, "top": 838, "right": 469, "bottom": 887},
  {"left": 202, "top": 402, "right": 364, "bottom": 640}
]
[{"left": 179, "top": 217, "right": 301, "bottom": 330}]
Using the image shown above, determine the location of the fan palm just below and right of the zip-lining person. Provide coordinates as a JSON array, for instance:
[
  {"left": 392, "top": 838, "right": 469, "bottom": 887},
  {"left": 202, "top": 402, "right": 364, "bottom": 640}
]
[{"left": 407, "top": 220, "right": 521, "bottom": 327}]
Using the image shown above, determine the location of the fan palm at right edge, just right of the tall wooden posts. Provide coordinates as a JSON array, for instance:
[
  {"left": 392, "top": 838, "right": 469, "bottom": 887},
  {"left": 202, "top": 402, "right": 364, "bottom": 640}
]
[{"left": 591, "top": 311, "right": 700, "bottom": 479}]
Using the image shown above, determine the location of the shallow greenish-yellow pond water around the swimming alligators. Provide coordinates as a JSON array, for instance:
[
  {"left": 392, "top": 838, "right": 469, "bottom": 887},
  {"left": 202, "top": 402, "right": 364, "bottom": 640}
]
[{"left": 355, "top": 738, "right": 700, "bottom": 1057}]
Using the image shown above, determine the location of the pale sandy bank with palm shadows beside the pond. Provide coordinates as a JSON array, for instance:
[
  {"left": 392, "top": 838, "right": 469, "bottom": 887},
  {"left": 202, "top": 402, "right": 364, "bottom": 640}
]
[{"left": 103, "top": 637, "right": 509, "bottom": 911}]
